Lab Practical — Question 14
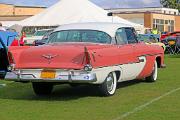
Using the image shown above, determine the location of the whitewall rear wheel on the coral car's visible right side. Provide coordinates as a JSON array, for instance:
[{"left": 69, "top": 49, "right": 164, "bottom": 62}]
[{"left": 99, "top": 72, "right": 117, "bottom": 96}]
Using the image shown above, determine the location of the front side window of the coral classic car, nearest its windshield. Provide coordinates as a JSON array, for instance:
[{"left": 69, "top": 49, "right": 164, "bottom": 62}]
[{"left": 125, "top": 28, "right": 137, "bottom": 44}]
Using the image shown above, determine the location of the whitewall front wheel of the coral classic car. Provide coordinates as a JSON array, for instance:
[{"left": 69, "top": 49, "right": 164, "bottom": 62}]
[{"left": 146, "top": 61, "right": 158, "bottom": 82}]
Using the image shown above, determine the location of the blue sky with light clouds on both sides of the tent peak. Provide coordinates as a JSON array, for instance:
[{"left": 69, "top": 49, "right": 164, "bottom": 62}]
[{"left": 0, "top": 0, "right": 161, "bottom": 8}]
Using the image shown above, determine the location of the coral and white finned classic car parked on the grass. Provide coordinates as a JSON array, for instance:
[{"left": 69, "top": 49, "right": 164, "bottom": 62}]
[{"left": 6, "top": 23, "right": 164, "bottom": 96}]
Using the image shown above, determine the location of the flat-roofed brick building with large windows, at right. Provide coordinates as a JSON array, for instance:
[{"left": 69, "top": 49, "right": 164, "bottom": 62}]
[{"left": 108, "top": 8, "right": 180, "bottom": 32}]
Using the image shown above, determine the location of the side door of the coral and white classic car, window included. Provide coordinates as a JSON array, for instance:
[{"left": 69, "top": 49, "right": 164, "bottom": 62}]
[{"left": 115, "top": 28, "right": 137, "bottom": 81}]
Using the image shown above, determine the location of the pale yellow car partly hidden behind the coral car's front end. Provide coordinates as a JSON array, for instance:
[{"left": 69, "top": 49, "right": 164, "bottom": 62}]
[{"left": 138, "top": 34, "right": 166, "bottom": 51}]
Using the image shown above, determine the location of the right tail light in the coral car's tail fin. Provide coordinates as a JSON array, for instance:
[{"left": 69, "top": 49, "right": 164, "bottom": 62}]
[{"left": 84, "top": 47, "right": 92, "bottom": 71}]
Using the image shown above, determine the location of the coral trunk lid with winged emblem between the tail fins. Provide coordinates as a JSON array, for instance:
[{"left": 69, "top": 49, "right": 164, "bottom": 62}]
[{"left": 16, "top": 43, "right": 111, "bottom": 69}]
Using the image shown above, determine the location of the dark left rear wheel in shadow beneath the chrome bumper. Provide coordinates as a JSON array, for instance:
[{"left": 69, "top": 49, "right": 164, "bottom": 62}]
[{"left": 32, "top": 82, "right": 53, "bottom": 95}]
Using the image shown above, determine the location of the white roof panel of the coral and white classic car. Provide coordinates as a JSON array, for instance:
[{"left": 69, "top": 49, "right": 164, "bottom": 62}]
[{"left": 54, "top": 22, "right": 132, "bottom": 37}]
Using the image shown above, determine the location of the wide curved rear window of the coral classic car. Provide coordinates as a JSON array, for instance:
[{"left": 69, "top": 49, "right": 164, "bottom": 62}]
[{"left": 48, "top": 30, "right": 111, "bottom": 44}]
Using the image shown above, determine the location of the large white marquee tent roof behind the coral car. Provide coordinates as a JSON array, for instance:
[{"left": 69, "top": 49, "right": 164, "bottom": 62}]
[{"left": 18, "top": 0, "right": 143, "bottom": 27}]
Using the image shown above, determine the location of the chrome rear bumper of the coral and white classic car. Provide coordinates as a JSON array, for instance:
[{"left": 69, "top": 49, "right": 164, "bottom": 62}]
[{"left": 5, "top": 72, "right": 97, "bottom": 83}]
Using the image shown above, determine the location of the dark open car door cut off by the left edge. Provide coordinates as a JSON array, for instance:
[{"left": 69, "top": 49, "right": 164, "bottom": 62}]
[{"left": 0, "top": 39, "right": 8, "bottom": 79}]
